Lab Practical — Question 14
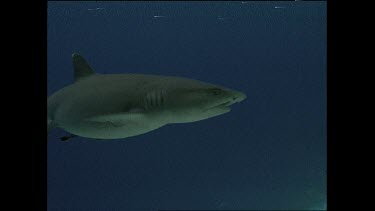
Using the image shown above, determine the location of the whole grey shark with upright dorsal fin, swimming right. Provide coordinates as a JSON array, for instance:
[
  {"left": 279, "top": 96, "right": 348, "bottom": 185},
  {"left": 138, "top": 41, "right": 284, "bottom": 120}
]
[{"left": 47, "top": 53, "right": 246, "bottom": 139}]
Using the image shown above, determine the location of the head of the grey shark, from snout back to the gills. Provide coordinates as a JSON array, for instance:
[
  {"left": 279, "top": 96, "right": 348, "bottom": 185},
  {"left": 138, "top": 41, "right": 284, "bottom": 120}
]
[{"left": 167, "top": 86, "right": 246, "bottom": 123}]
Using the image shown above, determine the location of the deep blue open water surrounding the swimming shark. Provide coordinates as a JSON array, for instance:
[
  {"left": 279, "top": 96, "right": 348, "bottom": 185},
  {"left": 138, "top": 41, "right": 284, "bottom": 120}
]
[{"left": 47, "top": 1, "right": 327, "bottom": 211}]
